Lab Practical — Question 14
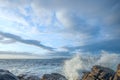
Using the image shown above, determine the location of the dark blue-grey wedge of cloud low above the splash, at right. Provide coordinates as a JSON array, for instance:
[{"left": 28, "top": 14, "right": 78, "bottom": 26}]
[{"left": 65, "top": 39, "right": 120, "bottom": 53}]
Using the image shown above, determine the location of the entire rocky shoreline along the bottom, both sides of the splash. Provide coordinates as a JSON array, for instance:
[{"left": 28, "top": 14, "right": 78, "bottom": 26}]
[{"left": 0, "top": 64, "right": 120, "bottom": 80}]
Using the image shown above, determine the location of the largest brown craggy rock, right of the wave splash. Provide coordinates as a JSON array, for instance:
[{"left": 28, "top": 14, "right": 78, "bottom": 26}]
[{"left": 82, "top": 65, "right": 115, "bottom": 80}]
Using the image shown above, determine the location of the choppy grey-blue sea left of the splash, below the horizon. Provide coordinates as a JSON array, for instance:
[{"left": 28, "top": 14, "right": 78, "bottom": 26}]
[{"left": 0, "top": 58, "right": 66, "bottom": 76}]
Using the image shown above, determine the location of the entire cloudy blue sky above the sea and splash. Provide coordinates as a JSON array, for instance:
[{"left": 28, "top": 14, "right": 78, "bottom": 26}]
[{"left": 0, "top": 0, "right": 120, "bottom": 58}]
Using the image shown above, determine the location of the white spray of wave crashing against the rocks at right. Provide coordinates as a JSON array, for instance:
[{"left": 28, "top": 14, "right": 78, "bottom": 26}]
[{"left": 63, "top": 51, "right": 120, "bottom": 80}]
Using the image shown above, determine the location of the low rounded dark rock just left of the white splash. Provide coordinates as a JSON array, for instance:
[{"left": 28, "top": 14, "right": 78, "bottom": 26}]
[{"left": 41, "top": 73, "right": 67, "bottom": 80}]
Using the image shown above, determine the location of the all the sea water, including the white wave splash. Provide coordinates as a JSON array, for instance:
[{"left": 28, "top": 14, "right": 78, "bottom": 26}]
[{"left": 0, "top": 51, "right": 120, "bottom": 80}]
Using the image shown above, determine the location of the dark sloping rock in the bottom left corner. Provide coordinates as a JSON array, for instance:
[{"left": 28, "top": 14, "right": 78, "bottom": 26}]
[{"left": 0, "top": 69, "right": 19, "bottom": 80}]
